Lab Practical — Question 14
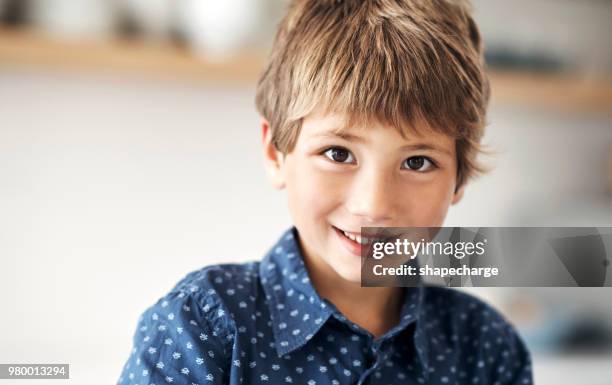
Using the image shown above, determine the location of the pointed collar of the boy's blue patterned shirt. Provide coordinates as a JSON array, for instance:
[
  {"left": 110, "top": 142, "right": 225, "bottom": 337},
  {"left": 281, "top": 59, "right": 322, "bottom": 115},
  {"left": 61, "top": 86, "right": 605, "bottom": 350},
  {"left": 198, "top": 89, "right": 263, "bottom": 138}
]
[{"left": 259, "top": 227, "right": 429, "bottom": 374}]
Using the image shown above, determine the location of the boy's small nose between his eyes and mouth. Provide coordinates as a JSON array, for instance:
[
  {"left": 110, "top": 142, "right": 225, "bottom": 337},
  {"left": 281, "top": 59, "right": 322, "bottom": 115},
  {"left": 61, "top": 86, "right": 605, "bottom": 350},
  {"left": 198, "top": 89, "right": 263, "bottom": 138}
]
[{"left": 346, "top": 169, "right": 398, "bottom": 227}]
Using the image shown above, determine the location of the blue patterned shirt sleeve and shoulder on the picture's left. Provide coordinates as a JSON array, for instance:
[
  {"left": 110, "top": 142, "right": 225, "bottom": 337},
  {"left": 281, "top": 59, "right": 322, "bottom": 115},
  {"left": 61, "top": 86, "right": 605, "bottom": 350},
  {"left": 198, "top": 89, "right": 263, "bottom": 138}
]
[{"left": 119, "top": 263, "right": 258, "bottom": 385}]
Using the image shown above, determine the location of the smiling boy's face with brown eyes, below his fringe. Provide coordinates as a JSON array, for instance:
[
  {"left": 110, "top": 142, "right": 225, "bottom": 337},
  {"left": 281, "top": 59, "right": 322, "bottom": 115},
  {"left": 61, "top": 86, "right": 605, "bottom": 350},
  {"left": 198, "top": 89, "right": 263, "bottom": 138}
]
[{"left": 262, "top": 109, "right": 462, "bottom": 283}]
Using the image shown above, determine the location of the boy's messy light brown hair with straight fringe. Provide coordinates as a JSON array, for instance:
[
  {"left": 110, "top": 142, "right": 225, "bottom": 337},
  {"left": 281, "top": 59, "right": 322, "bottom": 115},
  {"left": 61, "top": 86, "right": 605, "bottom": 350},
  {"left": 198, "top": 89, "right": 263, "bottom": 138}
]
[{"left": 256, "top": 0, "right": 489, "bottom": 188}]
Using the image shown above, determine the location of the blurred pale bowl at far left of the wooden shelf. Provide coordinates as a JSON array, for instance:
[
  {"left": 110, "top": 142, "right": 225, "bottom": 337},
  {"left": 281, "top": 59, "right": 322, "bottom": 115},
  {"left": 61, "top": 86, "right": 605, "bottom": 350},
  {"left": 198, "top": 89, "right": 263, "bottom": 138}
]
[{"left": 32, "top": 0, "right": 115, "bottom": 40}]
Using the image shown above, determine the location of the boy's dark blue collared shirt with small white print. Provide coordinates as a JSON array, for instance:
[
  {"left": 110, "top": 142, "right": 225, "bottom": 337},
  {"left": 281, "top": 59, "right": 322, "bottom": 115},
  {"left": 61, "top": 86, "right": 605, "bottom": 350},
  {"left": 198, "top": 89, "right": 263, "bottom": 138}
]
[{"left": 118, "top": 228, "right": 532, "bottom": 385}]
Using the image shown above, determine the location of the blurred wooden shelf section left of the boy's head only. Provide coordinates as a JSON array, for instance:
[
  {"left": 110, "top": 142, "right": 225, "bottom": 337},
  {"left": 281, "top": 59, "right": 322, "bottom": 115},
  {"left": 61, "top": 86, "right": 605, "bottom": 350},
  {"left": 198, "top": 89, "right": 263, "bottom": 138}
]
[{"left": 0, "top": 28, "right": 264, "bottom": 83}]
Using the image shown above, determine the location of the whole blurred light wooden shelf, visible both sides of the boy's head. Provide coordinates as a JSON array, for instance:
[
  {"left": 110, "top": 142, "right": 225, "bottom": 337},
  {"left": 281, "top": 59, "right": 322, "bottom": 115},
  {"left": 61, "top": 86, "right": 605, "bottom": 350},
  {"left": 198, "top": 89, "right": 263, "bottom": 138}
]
[{"left": 0, "top": 28, "right": 612, "bottom": 114}]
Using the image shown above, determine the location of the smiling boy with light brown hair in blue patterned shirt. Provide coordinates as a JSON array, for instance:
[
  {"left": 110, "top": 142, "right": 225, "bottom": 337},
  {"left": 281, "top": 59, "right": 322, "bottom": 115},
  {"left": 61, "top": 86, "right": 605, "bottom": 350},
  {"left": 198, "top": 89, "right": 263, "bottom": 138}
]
[{"left": 119, "top": 0, "right": 532, "bottom": 385}]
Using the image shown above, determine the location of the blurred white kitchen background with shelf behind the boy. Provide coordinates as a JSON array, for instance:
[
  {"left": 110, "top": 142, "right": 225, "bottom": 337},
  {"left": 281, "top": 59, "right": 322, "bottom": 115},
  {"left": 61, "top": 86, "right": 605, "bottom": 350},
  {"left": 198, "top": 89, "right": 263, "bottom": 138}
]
[{"left": 0, "top": 0, "right": 612, "bottom": 385}]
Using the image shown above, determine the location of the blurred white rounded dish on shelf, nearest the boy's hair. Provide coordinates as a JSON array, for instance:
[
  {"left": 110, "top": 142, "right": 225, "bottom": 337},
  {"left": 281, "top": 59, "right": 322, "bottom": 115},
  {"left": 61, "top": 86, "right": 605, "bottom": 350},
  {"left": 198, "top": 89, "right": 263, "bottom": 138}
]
[{"left": 178, "top": 0, "right": 262, "bottom": 61}]
